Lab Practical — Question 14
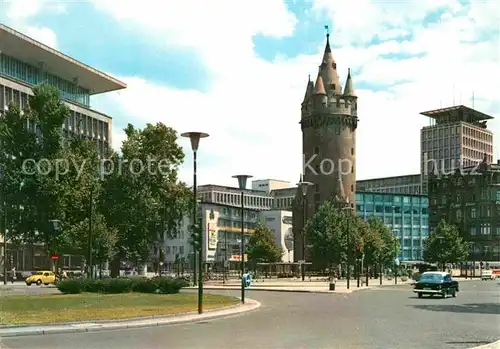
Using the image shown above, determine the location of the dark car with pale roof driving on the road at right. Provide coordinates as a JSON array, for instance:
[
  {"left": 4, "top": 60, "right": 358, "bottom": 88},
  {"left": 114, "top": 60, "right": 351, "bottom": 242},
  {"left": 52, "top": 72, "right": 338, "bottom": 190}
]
[{"left": 413, "top": 271, "right": 458, "bottom": 298}]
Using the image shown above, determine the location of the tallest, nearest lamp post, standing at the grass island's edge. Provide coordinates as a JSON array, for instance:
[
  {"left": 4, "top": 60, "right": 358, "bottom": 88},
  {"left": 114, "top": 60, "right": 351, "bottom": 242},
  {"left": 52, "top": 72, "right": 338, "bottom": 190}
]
[{"left": 181, "top": 132, "right": 208, "bottom": 314}]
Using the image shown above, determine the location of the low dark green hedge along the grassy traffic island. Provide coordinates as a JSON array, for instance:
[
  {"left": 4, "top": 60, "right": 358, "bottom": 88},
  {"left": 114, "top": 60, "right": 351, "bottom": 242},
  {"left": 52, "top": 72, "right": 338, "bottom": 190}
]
[{"left": 56, "top": 277, "right": 189, "bottom": 294}]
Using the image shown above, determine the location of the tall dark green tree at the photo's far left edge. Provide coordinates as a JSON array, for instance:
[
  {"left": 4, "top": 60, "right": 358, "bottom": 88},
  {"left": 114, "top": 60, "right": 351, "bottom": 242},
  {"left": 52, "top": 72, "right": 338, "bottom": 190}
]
[{"left": 0, "top": 85, "right": 70, "bottom": 251}]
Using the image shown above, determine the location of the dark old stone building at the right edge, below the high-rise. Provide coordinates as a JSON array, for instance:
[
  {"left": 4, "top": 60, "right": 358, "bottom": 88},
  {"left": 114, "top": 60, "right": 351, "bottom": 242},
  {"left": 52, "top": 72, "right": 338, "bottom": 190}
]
[{"left": 428, "top": 156, "right": 500, "bottom": 261}]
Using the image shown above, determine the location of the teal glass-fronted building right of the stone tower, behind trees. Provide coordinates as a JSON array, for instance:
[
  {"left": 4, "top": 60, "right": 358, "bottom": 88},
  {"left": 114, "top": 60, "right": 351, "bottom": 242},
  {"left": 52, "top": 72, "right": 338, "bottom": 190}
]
[{"left": 356, "top": 191, "right": 429, "bottom": 261}]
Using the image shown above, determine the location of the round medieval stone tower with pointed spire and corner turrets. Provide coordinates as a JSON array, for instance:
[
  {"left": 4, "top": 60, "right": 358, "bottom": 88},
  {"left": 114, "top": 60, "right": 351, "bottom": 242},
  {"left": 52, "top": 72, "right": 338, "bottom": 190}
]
[{"left": 293, "top": 34, "right": 358, "bottom": 261}]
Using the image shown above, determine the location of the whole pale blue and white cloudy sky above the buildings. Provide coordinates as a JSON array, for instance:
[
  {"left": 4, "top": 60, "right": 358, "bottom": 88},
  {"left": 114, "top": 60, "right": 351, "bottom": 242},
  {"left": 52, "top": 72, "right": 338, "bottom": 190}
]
[{"left": 0, "top": 0, "right": 500, "bottom": 186}]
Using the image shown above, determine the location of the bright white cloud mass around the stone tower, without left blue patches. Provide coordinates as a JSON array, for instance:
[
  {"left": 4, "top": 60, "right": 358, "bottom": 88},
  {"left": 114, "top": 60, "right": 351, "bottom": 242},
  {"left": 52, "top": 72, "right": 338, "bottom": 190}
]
[{"left": 94, "top": 0, "right": 500, "bottom": 188}]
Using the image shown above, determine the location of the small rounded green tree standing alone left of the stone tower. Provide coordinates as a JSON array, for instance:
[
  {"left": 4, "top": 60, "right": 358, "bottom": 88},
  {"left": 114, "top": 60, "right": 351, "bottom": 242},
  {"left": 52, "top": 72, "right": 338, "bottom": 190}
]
[{"left": 246, "top": 224, "right": 283, "bottom": 266}]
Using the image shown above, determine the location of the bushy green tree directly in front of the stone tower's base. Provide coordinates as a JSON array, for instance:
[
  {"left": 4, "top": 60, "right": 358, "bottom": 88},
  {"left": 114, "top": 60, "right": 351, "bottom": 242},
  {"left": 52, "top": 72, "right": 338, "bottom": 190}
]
[{"left": 306, "top": 201, "right": 364, "bottom": 269}]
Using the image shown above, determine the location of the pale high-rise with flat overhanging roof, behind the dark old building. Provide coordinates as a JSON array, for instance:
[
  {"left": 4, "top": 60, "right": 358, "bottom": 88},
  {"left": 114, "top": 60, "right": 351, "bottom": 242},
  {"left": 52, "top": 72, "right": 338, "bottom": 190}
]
[{"left": 420, "top": 105, "right": 493, "bottom": 193}]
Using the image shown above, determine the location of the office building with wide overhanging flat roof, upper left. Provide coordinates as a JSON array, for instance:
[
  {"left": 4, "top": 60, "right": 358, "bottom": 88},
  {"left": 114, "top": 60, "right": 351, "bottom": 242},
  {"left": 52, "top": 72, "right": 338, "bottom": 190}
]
[{"left": 0, "top": 24, "right": 126, "bottom": 154}]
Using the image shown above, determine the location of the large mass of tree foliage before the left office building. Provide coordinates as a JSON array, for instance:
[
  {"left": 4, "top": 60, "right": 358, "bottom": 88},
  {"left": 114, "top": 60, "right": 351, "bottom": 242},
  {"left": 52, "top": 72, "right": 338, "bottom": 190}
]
[{"left": 0, "top": 85, "right": 191, "bottom": 274}]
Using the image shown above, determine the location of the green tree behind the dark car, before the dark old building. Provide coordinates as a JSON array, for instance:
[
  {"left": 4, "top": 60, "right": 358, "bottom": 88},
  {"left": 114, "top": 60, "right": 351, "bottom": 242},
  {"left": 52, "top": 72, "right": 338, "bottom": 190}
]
[{"left": 424, "top": 220, "right": 469, "bottom": 270}]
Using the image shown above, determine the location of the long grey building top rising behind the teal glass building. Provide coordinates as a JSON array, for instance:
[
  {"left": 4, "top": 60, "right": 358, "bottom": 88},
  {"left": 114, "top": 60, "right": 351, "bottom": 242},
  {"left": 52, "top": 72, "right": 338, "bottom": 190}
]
[{"left": 356, "top": 174, "right": 422, "bottom": 195}]
